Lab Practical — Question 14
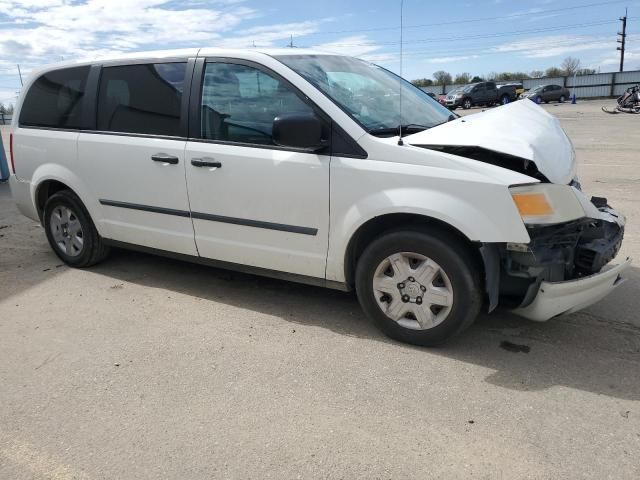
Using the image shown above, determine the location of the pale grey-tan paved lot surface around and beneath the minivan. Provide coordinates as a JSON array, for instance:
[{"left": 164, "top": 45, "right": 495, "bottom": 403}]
[{"left": 0, "top": 101, "right": 640, "bottom": 480}]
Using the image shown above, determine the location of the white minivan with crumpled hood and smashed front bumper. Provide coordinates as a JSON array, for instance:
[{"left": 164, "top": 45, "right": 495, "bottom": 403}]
[{"left": 10, "top": 49, "right": 629, "bottom": 345}]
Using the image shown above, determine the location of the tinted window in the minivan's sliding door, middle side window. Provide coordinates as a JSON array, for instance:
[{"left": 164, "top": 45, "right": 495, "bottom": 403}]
[{"left": 97, "top": 62, "right": 187, "bottom": 136}]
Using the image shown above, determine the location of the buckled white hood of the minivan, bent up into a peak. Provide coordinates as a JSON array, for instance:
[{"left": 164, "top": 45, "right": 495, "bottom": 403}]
[{"left": 405, "top": 100, "right": 576, "bottom": 185}]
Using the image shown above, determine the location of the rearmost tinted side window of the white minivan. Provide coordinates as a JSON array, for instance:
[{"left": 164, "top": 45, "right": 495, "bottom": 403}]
[{"left": 20, "top": 66, "right": 89, "bottom": 129}]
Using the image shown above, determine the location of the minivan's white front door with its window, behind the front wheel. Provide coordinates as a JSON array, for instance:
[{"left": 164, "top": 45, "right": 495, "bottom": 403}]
[{"left": 186, "top": 60, "right": 330, "bottom": 278}]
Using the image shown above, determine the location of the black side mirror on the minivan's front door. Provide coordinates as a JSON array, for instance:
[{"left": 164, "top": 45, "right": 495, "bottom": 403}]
[{"left": 271, "top": 113, "right": 327, "bottom": 152}]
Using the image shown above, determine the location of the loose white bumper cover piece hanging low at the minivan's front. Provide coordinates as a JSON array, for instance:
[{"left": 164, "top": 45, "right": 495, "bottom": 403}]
[{"left": 513, "top": 258, "right": 631, "bottom": 322}]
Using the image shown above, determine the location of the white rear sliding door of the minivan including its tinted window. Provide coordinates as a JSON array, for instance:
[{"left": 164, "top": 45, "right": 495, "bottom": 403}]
[{"left": 76, "top": 61, "right": 197, "bottom": 255}]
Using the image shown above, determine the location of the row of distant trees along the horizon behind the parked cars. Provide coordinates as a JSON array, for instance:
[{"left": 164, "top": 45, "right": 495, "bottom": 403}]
[{"left": 411, "top": 57, "right": 596, "bottom": 87}]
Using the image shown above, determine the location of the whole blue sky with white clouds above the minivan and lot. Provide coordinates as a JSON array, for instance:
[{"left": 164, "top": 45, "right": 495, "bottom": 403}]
[{"left": 0, "top": 0, "right": 640, "bottom": 105}]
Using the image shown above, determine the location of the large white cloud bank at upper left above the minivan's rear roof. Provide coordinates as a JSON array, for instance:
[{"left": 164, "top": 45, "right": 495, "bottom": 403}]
[{"left": 0, "top": 0, "right": 257, "bottom": 64}]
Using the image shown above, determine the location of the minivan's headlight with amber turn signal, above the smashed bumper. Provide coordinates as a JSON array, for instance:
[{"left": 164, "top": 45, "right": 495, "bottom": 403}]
[{"left": 509, "top": 183, "right": 586, "bottom": 225}]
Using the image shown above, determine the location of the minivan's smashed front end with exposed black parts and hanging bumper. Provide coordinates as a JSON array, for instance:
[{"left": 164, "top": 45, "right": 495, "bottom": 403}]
[{"left": 484, "top": 193, "right": 630, "bottom": 321}]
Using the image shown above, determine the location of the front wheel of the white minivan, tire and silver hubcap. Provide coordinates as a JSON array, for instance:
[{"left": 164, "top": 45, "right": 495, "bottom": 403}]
[{"left": 356, "top": 230, "right": 483, "bottom": 346}]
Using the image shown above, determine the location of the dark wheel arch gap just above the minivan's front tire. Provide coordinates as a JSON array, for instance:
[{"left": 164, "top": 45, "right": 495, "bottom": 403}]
[{"left": 344, "top": 213, "right": 484, "bottom": 288}]
